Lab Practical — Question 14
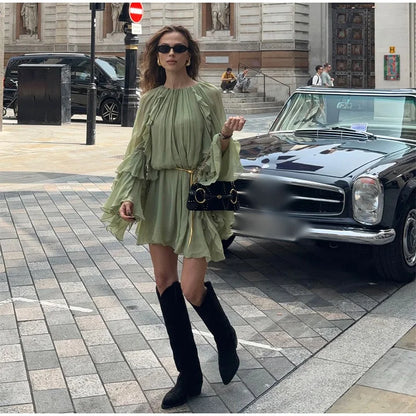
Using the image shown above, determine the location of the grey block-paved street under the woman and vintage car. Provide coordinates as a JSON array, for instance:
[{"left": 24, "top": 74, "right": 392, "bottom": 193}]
[{"left": 0, "top": 115, "right": 404, "bottom": 413}]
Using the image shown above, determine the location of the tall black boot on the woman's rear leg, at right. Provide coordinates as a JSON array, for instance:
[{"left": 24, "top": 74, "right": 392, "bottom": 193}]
[{"left": 192, "top": 282, "right": 240, "bottom": 384}]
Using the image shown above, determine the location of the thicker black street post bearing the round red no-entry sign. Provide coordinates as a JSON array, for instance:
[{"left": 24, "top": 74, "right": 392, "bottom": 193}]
[{"left": 119, "top": 3, "right": 139, "bottom": 127}]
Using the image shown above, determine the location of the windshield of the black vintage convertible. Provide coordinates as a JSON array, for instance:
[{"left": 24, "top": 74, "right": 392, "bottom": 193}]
[{"left": 271, "top": 93, "right": 416, "bottom": 141}]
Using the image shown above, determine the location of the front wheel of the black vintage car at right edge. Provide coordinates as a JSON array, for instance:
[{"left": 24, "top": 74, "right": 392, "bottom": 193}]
[{"left": 375, "top": 203, "right": 416, "bottom": 283}]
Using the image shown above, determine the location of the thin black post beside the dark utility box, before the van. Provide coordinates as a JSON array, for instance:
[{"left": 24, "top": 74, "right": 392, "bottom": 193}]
[{"left": 87, "top": 3, "right": 105, "bottom": 145}]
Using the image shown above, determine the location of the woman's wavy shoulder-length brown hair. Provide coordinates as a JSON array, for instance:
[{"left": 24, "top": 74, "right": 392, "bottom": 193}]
[{"left": 140, "top": 25, "right": 201, "bottom": 92}]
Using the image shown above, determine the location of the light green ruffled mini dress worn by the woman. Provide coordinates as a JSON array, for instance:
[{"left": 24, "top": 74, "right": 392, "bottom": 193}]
[{"left": 101, "top": 81, "right": 241, "bottom": 261}]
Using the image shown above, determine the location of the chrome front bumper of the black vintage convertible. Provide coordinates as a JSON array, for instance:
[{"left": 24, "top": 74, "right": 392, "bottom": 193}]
[{"left": 233, "top": 211, "right": 396, "bottom": 245}]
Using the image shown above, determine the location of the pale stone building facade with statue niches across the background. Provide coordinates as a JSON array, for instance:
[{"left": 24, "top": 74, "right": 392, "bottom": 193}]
[{"left": 4, "top": 1, "right": 416, "bottom": 105}]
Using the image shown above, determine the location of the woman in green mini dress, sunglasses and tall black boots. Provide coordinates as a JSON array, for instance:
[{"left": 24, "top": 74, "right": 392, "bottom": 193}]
[{"left": 102, "top": 26, "right": 245, "bottom": 409}]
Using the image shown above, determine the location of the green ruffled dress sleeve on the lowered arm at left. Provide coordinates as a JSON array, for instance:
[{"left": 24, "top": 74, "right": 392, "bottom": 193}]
[{"left": 101, "top": 91, "right": 163, "bottom": 240}]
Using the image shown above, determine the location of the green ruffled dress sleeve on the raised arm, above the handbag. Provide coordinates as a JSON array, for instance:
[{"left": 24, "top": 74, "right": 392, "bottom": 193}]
[{"left": 196, "top": 84, "right": 243, "bottom": 185}]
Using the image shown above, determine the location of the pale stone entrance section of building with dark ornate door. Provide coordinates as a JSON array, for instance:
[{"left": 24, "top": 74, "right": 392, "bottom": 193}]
[{"left": 309, "top": 2, "right": 416, "bottom": 88}]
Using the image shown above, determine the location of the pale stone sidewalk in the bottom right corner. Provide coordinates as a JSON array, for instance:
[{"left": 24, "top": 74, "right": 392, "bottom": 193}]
[{"left": 245, "top": 282, "right": 416, "bottom": 413}]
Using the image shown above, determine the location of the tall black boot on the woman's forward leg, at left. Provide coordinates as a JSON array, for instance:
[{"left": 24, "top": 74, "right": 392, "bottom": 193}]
[{"left": 156, "top": 282, "right": 202, "bottom": 409}]
